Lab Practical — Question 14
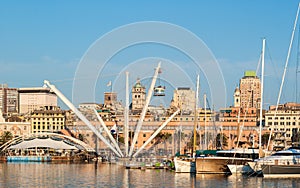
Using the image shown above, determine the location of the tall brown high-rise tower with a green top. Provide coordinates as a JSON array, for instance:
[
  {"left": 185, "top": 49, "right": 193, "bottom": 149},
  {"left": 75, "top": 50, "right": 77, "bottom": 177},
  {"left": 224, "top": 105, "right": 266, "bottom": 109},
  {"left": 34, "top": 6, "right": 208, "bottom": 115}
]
[{"left": 240, "top": 71, "right": 261, "bottom": 108}]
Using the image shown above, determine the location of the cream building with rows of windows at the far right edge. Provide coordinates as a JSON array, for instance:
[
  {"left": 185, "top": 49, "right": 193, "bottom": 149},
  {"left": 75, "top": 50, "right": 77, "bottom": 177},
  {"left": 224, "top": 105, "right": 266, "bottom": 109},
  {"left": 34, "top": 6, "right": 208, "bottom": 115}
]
[{"left": 265, "top": 103, "right": 300, "bottom": 150}]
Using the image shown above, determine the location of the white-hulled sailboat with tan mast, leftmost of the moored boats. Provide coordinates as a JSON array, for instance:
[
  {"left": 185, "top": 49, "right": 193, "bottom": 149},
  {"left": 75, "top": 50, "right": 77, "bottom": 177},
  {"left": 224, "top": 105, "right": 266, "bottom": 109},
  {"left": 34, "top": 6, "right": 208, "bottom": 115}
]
[{"left": 174, "top": 75, "right": 199, "bottom": 173}]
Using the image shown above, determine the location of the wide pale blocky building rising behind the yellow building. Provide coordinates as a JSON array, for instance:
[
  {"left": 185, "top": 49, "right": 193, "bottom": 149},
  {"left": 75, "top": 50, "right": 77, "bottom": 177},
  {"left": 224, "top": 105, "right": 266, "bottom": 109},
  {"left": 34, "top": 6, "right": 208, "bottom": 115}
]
[{"left": 18, "top": 87, "right": 57, "bottom": 114}]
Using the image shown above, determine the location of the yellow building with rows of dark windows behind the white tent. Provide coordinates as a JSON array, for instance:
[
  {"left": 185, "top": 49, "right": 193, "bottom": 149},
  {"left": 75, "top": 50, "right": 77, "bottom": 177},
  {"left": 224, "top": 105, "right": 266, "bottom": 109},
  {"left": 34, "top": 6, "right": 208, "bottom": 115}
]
[{"left": 27, "top": 106, "right": 65, "bottom": 133}]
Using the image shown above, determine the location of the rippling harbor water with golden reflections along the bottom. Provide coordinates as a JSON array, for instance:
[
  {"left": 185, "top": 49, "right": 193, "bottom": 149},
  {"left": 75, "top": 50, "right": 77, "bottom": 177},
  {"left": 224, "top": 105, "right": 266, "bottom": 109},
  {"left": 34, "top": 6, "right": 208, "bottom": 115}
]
[{"left": 0, "top": 163, "right": 300, "bottom": 188}]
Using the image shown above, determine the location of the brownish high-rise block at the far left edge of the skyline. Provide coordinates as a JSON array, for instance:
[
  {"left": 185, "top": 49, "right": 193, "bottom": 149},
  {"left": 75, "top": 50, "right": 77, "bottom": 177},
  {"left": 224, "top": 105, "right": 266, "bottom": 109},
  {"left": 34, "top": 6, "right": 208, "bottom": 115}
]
[{"left": 0, "top": 84, "right": 19, "bottom": 118}]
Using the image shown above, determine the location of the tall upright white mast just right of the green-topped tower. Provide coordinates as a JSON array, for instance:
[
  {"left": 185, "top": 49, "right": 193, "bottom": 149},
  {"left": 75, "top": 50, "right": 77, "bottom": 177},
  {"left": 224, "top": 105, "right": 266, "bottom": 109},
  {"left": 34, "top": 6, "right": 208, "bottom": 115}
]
[{"left": 259, "top": 38, "right": 266, "bottom": 149}]
